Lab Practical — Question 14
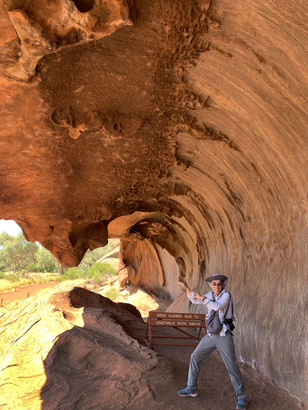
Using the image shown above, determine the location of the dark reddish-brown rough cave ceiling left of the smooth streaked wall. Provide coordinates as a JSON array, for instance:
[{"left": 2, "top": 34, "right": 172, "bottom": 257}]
[{"left": 1, "top": 0, "right": 214, "bottom": 266}]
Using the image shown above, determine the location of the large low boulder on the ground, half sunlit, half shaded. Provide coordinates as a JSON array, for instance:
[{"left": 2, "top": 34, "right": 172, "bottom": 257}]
[{"left": 0, "top": 288, "right": 168, "bottom": 410}]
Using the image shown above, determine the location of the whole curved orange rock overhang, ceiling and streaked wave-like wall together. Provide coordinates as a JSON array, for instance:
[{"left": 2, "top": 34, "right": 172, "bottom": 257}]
[{"left": 0, "top": 0, "right": 308, "bottom": 403}]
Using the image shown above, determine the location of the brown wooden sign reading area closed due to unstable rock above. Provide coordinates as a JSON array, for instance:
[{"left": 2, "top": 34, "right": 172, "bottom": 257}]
[{"left": 144, "top": 312, "right": 206, "bottom": 349}]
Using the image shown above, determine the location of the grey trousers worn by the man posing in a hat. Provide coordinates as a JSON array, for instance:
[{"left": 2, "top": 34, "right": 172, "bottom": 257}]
[{"left": 187, "top": 331, "right": 247, "bottom": 399}]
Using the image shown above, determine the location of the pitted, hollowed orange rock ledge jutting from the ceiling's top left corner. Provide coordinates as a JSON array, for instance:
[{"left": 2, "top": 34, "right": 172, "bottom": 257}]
[{"left": 3, "top": 0, "right": 132, "bottom": 81}]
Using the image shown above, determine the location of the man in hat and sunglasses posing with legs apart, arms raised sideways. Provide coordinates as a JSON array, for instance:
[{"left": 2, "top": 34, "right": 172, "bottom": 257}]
[{"left": 176, "top": 274, "right": 247, "bottom": 410}]
